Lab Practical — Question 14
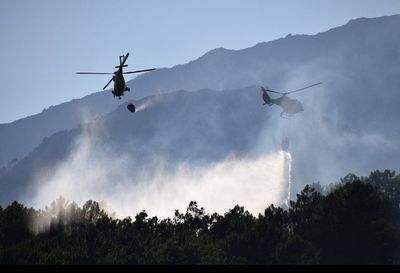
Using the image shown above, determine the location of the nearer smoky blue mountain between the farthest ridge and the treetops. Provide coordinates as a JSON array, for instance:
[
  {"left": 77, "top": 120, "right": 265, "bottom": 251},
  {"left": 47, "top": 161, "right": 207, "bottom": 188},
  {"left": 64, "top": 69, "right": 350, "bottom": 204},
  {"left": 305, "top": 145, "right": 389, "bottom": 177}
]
[{"left": 0, "top": 86, "right": 400, "bottom": 204}]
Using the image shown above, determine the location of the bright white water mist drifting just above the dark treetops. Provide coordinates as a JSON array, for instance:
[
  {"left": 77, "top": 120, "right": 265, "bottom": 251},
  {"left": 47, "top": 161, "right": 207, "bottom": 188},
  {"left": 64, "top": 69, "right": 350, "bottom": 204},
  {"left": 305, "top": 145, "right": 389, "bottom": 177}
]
[{"left": 29, "top": 116, "right": 288, "bottom": 218}]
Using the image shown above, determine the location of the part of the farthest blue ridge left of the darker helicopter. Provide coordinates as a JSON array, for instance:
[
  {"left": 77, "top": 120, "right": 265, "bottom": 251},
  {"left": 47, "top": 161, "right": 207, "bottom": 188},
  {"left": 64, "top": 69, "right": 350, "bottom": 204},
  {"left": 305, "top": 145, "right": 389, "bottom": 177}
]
[{"left": 0, "top": 92, "right": 118, "bottom": 167}]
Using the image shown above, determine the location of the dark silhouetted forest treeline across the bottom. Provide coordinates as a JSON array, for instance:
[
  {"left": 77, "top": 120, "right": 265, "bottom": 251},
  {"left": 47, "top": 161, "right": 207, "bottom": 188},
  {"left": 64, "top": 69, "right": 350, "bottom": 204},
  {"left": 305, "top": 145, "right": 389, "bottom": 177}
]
[{"left": 0, "top": 170, "right": 400, "bottom": 264}]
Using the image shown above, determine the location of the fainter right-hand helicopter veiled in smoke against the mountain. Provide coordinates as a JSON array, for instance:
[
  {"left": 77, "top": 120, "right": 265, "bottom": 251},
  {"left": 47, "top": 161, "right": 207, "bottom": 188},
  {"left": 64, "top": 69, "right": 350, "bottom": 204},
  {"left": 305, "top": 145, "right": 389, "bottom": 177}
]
[{"left": 261, "top": 82, "right": 322, "bottom": 117}]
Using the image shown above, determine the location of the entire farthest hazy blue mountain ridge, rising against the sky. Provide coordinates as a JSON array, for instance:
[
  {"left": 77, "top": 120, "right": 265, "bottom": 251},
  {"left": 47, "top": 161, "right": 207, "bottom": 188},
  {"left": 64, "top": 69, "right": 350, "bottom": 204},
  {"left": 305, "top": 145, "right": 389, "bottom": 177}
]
[{"left": 0, "top": 15, "right": 400, "bottom": 169}]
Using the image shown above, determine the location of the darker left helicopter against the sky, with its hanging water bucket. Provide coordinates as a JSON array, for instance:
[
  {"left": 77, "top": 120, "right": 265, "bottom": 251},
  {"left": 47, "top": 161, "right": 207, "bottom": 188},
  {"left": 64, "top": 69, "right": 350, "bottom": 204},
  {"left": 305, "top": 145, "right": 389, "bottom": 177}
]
[{"left": 76, "top": 52, "right": 155, "bottom": 109}]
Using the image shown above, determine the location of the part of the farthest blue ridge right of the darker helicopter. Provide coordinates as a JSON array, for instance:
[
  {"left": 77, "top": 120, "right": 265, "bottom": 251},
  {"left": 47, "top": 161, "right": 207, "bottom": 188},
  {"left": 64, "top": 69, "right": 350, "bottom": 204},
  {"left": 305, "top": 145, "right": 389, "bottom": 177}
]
[{"left": 126, "top": 15, "right": 400, "bottom": 136}]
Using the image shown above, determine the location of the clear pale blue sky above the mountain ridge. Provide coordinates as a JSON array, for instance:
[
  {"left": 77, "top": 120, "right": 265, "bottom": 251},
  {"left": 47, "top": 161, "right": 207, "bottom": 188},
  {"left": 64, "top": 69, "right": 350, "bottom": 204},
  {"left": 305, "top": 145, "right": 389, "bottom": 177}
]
[{"left": 0, "top": 0, "right": 400, "bottom": 123}]
